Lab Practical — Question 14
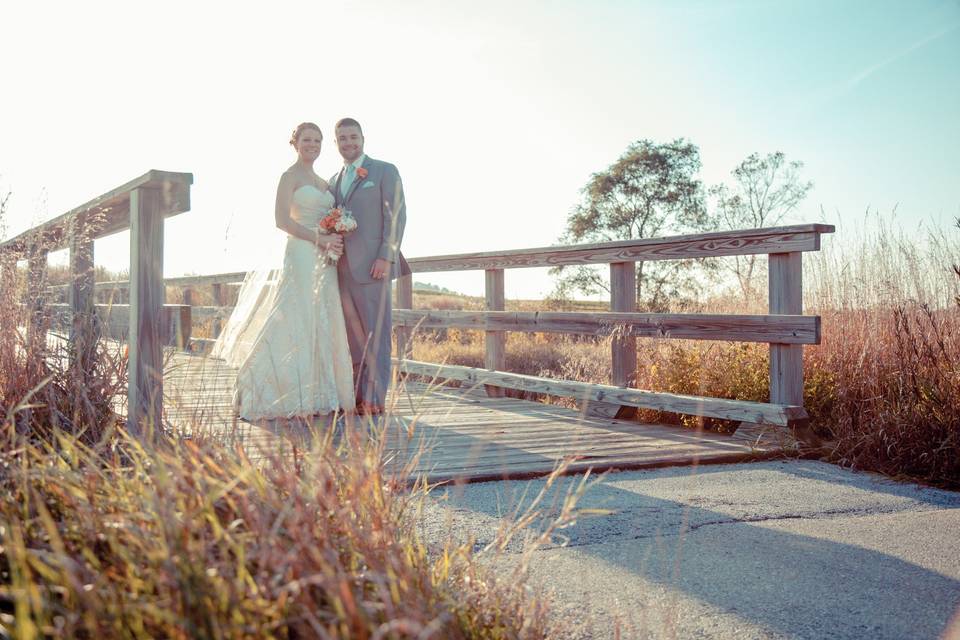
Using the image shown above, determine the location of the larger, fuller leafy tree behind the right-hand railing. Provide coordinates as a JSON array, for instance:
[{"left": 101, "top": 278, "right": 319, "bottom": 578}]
[{"left": 551, "top": 138, "right": 709, "bottom": 311}]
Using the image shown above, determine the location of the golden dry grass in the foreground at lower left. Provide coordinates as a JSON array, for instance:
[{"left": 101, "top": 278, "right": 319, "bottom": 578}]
[{"left": 0, "top": 260, "right": 575, "bottom": 639}]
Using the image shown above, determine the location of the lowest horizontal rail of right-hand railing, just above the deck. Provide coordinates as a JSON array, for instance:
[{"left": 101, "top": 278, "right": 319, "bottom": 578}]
[{"left": 394, "top": 360, "right": 807, "bottom": 427}]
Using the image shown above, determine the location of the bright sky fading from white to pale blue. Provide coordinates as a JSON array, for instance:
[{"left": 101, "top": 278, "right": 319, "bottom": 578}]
[{"left": 0, "top": 0, "right": 960, "bottom": 297}]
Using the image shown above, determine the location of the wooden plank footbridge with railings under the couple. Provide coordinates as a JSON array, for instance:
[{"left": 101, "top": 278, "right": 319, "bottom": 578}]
[{"left": 0, "top": 171, "right": 834, "bottom": 480}]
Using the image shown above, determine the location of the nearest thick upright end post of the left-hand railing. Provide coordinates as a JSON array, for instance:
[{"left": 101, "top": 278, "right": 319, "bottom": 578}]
[{"left": 127, "top": 187, "right": 164, "bottom": 437}]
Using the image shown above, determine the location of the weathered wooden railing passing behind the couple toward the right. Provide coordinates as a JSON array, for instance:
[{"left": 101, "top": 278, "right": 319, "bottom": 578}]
[{"left": 41, "top": 224, "right": 834, "bottom": 436}]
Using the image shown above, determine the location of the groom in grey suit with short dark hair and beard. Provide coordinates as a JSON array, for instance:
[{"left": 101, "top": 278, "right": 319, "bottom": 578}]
[{"left": 330, "top": 118, "right": 410, "bottom": 415}]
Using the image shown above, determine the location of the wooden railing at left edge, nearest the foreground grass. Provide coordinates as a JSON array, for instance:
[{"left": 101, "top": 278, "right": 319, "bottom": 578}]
[{"left": 0, "top": 170, "right": 193, "bottom": 435}]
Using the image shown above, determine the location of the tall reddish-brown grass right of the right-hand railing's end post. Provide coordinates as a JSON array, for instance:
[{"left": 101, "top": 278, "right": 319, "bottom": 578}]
[{"left": 805, "top": 218, "right": 960, "bottom": 487}]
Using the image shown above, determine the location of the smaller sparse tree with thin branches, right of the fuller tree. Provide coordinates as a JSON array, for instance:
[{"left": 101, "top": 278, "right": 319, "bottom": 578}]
[{"left": 710, "top": 151, "right": 813, "bottom": 300}]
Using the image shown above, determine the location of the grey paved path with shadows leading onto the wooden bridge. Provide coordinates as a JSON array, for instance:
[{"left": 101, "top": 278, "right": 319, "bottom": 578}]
[{"left": 423, "top": 460, "right": 960, "bottom": 640}]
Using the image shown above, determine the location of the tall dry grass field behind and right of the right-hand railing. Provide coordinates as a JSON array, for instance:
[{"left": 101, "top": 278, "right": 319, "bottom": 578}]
[{"left": 413, "top": 216, "right": 960, "bottom": 487}]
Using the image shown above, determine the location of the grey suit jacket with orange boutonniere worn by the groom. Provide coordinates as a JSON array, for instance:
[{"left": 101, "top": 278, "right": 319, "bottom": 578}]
[{"left": 330, "top": 156, "right": 410, "bottom": 283}]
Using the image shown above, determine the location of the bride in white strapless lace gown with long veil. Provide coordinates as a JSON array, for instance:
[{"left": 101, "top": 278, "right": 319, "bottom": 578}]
[{"left": 212, "top": 122, "right": 355, "bottom": 421}]
